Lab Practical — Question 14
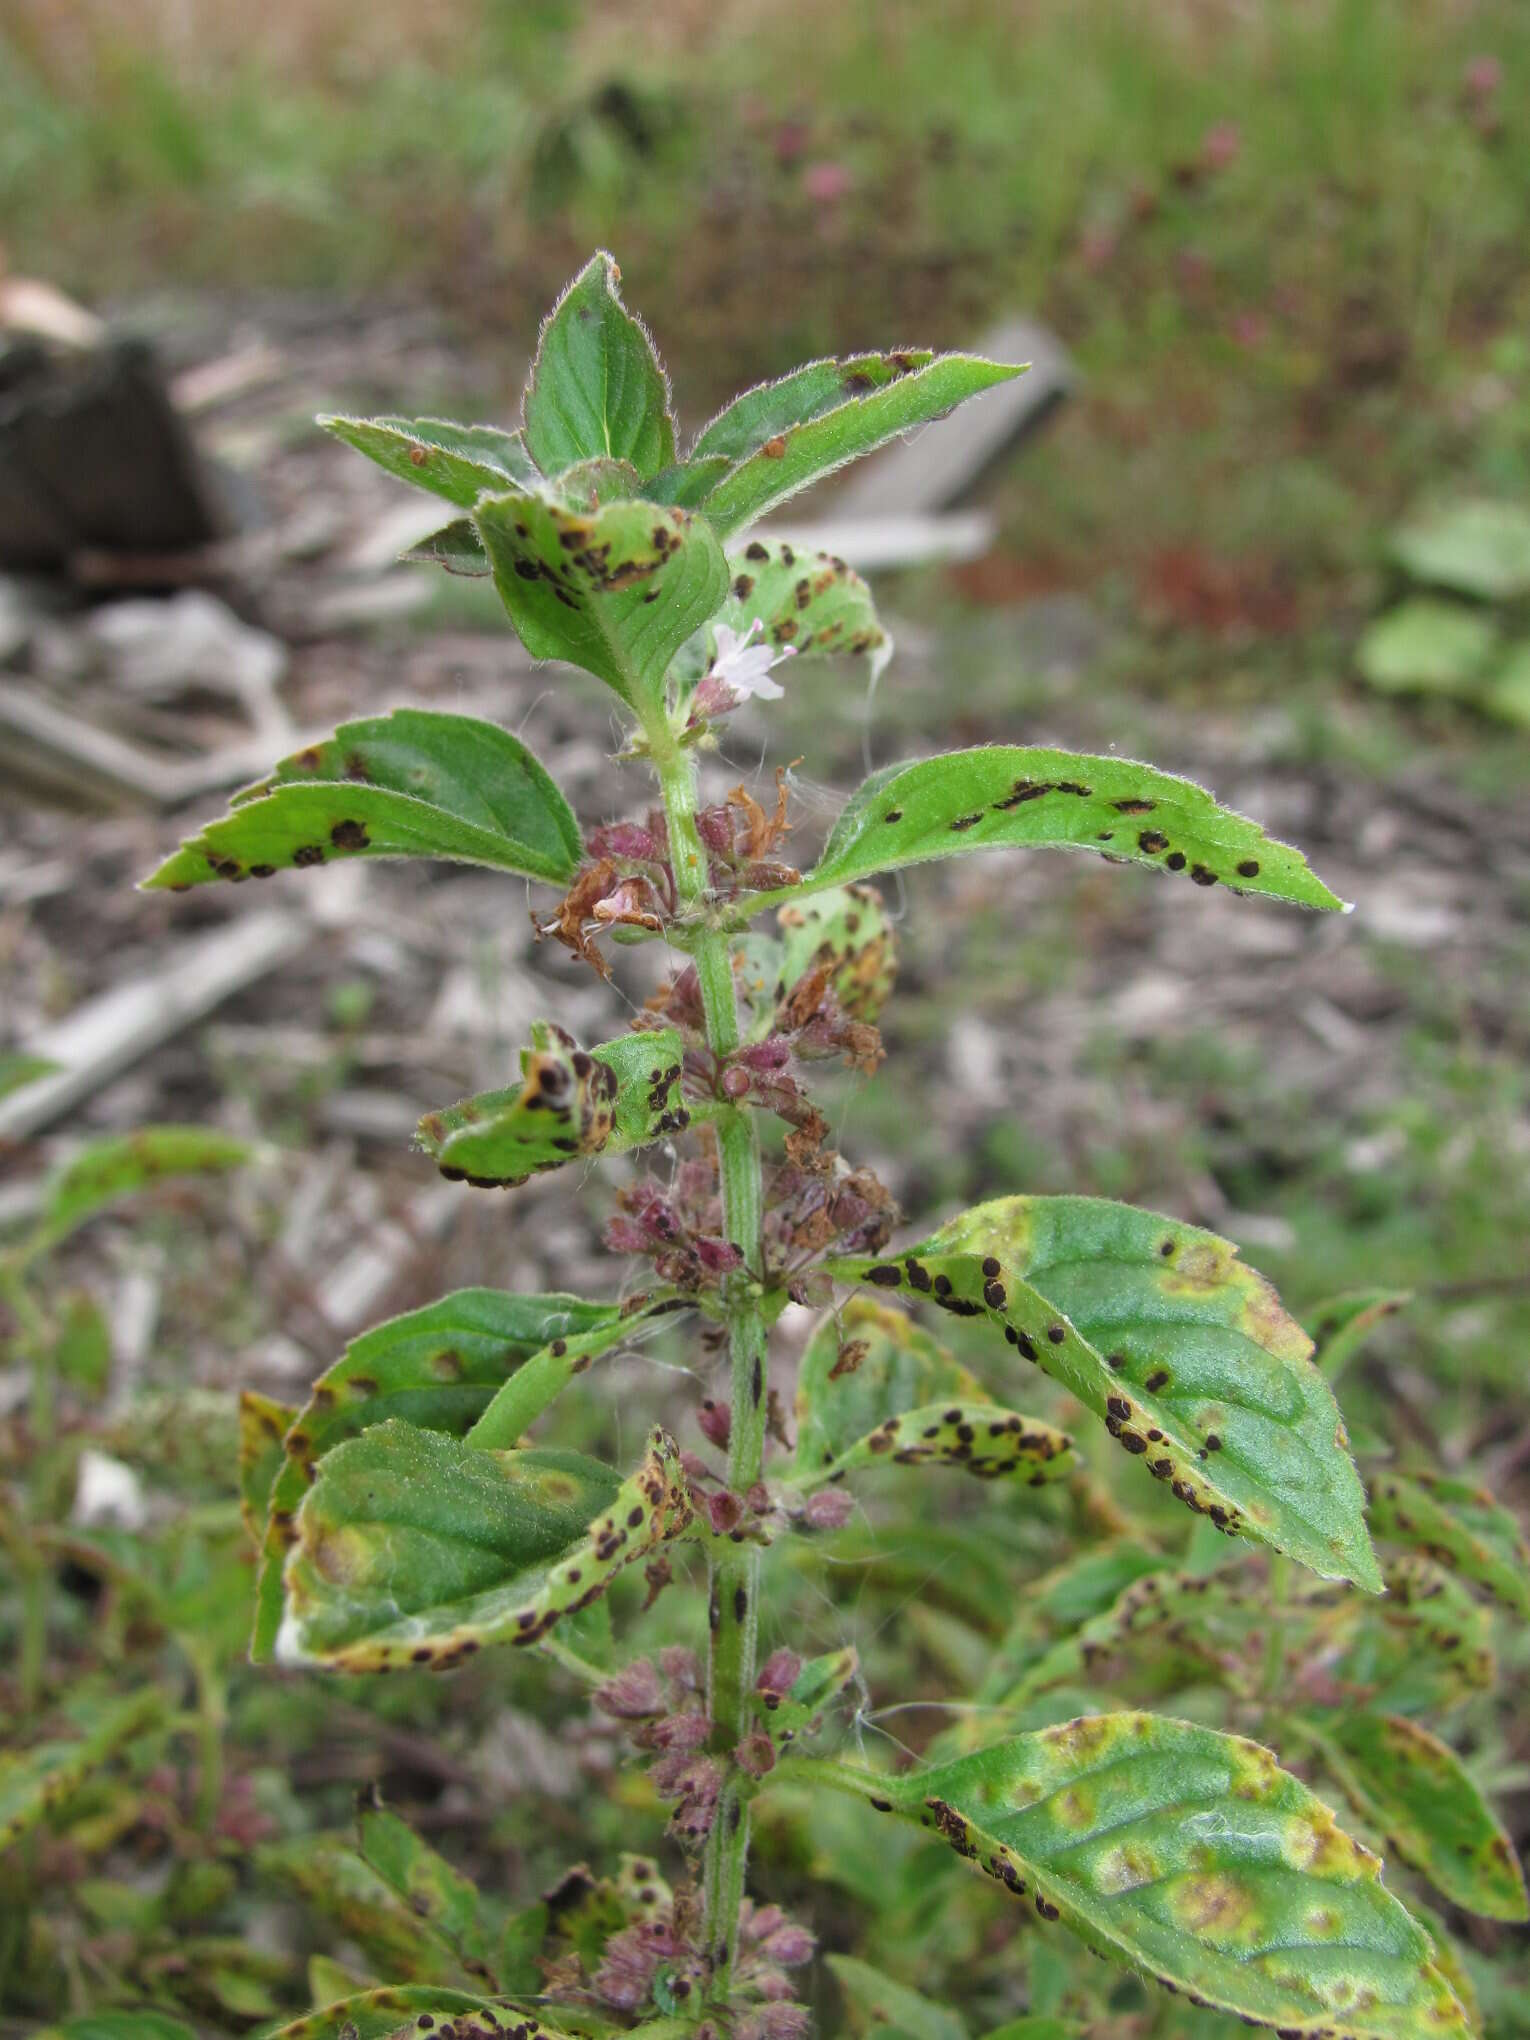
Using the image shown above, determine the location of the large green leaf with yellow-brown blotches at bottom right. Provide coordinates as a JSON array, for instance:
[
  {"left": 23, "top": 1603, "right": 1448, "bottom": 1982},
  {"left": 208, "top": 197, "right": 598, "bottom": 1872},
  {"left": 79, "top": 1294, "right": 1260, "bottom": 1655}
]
[{"left": 845, "top": 1714, "right": 1469, "bottom": 2040}]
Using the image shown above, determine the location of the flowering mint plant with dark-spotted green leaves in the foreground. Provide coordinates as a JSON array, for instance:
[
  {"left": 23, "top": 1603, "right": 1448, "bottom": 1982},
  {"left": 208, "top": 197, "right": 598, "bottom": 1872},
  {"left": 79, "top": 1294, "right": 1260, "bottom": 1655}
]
[{"left": 149, "top": 255, "right": 1526, "bottom": 2040}]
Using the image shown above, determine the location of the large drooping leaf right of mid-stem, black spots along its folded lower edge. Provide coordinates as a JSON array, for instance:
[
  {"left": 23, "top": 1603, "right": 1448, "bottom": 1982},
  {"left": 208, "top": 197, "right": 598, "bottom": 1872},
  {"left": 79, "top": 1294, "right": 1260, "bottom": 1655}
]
[{"left": 826, "top": 1197, "right": 1381, "bottom": 1593}]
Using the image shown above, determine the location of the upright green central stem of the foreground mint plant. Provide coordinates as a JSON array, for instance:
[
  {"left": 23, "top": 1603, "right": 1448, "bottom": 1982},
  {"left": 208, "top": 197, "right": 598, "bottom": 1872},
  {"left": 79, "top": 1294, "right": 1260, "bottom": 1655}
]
[{"left": 649, "top": 728, "right": 769, "bottom": 1999}]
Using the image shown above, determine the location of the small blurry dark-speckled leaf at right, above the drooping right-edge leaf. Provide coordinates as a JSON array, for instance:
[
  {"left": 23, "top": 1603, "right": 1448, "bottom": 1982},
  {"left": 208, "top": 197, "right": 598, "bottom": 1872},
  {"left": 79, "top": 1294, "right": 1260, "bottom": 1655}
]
[{"left": 1322, "top": 1557, "right": 1497, "bottom": 1714}]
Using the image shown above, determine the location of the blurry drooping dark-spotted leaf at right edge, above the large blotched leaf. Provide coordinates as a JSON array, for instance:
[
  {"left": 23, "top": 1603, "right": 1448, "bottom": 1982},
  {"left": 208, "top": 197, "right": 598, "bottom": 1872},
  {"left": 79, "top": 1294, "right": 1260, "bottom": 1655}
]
[{"left": 1302, "top": 1710, "right": 1530, "bottom": 1920}]
